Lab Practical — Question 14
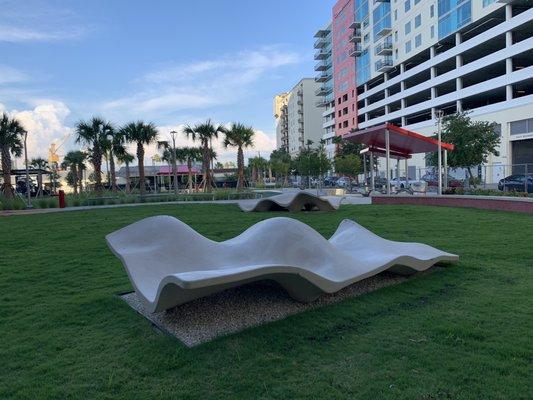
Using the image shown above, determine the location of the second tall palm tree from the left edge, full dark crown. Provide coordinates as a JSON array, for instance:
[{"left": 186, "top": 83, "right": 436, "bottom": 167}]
[{"left": 75, "top": 118, "right": 113, "bottom": 194}]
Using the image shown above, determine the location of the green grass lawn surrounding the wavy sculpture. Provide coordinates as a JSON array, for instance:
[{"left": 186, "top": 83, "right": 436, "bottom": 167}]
[{"left": 0, "top": 205, "right": 533, "bottom": 400}]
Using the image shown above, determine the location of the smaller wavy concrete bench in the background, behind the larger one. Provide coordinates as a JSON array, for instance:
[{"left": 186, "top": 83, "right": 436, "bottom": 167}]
[{"left": 239, "top": 190, "right": 343, "bottom": 212}]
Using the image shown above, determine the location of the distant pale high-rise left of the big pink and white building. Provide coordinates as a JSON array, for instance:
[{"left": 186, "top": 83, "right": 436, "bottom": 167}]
[{"left": 274, "top": 78, "right": 322, "bottom": 157}]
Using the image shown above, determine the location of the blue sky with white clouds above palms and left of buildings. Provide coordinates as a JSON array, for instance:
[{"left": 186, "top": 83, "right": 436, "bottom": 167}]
[{"left": 0, "top": 0, "right": 335, "bottom": 161}]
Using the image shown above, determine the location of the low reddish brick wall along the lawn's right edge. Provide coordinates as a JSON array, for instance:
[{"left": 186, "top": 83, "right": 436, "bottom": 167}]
[{"left": 372, "top": 195, "right": 533, "bottom": 214}]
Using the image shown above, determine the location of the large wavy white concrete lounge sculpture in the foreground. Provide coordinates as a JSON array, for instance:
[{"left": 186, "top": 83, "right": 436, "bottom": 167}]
[{"left": 106, "top": 216, "right": 459, "bottom": 312}]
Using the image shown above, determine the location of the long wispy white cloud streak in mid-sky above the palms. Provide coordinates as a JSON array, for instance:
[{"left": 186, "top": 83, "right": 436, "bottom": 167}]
[{"left": 102, "top": 46, "right": 302, "bottom": 117}]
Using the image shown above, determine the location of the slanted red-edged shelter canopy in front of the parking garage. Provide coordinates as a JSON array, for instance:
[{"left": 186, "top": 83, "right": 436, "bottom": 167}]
[{"left": 343, "top": 123, "right": 454, "bottom": 158}]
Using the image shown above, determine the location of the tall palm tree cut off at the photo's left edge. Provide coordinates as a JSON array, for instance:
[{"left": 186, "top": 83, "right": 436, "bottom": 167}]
[{"left": 0, "top": 113, "right": 26, "bottom": 198}]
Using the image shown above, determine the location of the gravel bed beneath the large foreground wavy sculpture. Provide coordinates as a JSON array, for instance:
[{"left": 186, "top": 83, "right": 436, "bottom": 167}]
[{"left": 121, "top": 273, "right": 432, "bottom": 347}]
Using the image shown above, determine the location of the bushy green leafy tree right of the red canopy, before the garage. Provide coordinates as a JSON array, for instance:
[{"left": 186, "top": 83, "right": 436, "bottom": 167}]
[{"left": 426, "top": 112, "right": 500, "bottom": 186}]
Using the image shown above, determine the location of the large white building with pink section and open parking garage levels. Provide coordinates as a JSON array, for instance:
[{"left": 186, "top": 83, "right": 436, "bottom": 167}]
[{"left": 314, "top": 0, "right": 533, "bottom": 169}]
